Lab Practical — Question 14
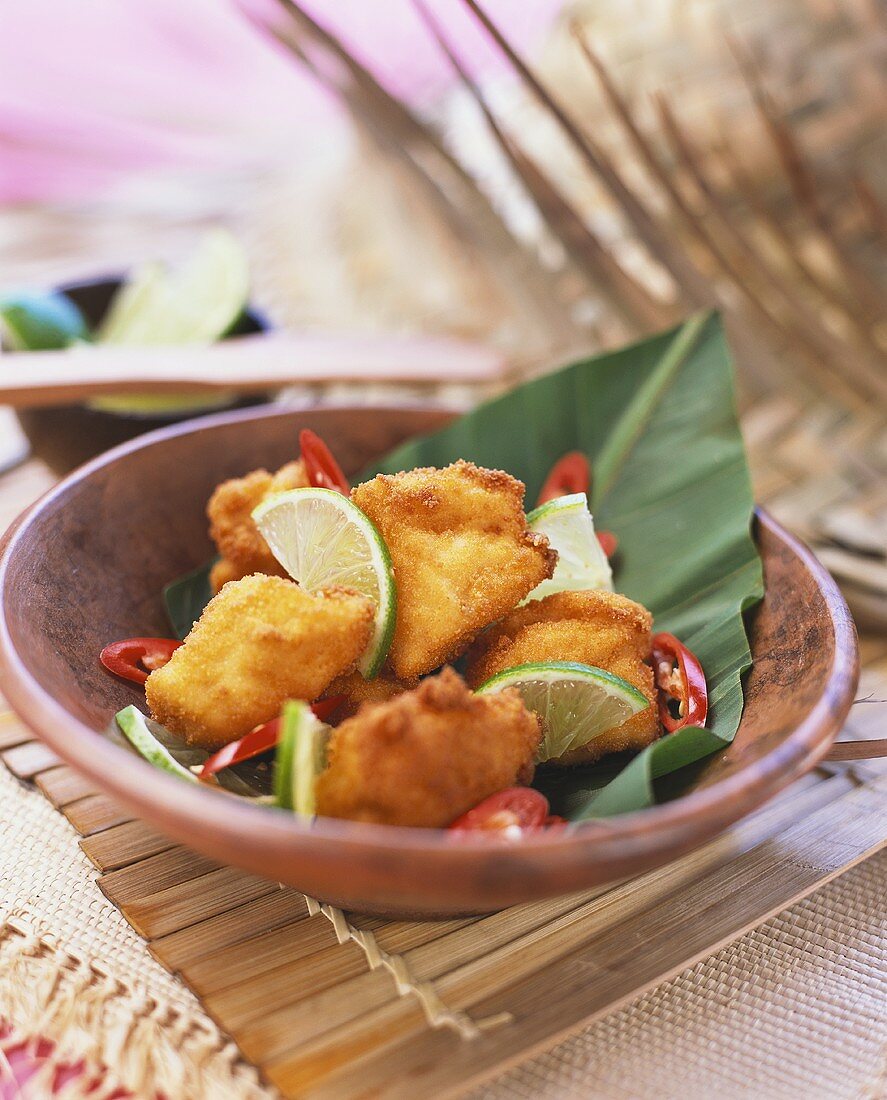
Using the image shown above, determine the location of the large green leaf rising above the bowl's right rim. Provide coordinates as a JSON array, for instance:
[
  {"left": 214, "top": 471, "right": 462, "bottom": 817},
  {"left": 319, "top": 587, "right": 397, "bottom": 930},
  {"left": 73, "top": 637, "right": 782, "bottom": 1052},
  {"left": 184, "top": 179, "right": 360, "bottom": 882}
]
[{"left": 363, "top": 314, "right": 764, "bottom": 821}]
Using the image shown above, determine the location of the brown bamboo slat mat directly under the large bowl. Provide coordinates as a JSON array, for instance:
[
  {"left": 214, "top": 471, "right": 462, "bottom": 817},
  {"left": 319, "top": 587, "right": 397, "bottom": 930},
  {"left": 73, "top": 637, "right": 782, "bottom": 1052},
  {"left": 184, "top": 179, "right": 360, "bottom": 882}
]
[{"left": 0, "top": 695, "right": 887, "bottom": 1100}]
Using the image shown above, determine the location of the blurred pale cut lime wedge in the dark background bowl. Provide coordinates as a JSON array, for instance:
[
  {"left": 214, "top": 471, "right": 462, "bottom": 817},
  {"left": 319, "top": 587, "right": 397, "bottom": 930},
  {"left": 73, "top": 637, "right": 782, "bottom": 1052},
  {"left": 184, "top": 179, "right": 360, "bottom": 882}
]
[{"left": 90, "top": 229, "right": 250, "bottom": 416}]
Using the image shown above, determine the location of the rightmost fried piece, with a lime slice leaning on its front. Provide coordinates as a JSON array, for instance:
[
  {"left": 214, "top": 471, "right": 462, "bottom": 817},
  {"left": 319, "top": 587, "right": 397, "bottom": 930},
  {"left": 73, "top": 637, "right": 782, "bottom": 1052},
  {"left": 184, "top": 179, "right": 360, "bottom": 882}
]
[{"left": 466, "top": 589, "right": 660, "bottom": 765}]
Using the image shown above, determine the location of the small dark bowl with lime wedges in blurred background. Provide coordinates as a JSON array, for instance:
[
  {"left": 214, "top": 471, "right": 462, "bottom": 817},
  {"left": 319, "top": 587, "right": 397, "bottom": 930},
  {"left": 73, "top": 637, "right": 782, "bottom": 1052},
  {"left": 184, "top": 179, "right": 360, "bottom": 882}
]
[{"left": 12, "top": 277, "right": 271, "bottom": 474}]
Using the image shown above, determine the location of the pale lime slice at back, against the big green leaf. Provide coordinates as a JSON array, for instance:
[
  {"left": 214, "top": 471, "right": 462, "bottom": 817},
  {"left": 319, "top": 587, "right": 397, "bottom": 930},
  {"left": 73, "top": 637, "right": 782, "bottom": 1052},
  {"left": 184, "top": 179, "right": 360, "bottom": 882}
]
[{"left": 525, "top": 493, "right": 613, "bottom": 602}]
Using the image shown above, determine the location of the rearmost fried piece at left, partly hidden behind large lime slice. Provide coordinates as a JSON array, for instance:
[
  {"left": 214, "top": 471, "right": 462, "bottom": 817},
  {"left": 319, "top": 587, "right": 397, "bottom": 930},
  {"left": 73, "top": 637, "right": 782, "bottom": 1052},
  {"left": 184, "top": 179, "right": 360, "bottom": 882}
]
[{"left": 207, "top": 460, "right": 308, "bottom": 592}]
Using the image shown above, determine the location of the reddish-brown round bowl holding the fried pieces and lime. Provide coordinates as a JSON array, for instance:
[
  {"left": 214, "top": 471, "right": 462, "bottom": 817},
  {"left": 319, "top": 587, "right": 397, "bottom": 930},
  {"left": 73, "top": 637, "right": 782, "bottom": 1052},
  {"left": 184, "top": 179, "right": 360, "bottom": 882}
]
[{"left": 0, "top": 408, "right": 857, "bottom": 915}]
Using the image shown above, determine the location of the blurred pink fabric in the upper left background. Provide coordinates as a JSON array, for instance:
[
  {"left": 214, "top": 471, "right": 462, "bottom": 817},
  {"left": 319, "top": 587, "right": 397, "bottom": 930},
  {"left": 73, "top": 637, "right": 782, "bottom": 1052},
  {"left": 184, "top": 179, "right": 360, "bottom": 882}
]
[{"left": 0, "top": 0, "right": 562, "bottom": 204}]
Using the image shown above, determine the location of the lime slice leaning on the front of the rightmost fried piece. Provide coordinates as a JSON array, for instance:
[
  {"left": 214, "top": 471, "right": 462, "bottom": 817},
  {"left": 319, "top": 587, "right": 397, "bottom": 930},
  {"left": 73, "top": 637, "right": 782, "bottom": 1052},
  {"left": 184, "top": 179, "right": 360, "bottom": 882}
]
[{"left": 478, "top": 661, "right": 649, "bottom": 763}]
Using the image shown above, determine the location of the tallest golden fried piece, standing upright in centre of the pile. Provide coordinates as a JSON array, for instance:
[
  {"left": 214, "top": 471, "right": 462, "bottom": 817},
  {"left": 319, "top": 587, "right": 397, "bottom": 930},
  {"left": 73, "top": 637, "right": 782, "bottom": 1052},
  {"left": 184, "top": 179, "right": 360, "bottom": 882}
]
[{"left": 351, "top": 461, "right": 557, "bottom": 680}]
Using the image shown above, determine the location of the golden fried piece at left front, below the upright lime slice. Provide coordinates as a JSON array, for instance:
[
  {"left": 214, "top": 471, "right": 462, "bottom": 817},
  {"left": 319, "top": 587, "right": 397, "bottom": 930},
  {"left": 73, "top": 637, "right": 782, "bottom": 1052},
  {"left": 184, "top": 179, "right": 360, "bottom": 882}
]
[{"left": 145, "top": 573, "right": 373, "bottom": 750}]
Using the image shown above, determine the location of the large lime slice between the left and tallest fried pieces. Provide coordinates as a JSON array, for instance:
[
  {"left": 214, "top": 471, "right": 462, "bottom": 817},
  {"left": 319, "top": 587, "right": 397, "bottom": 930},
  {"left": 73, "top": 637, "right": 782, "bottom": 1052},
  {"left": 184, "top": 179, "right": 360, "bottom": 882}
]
[{"left": 252, "top": 488, "right": 397, "bottom": 680}]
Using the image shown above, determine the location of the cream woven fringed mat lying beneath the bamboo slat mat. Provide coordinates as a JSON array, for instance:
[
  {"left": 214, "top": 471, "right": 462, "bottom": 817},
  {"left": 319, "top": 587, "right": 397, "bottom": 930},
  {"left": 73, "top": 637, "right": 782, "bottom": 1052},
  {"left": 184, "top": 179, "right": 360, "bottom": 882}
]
[{"left": 0, "top": 752, "right": 887, "bottom": 1100}]
